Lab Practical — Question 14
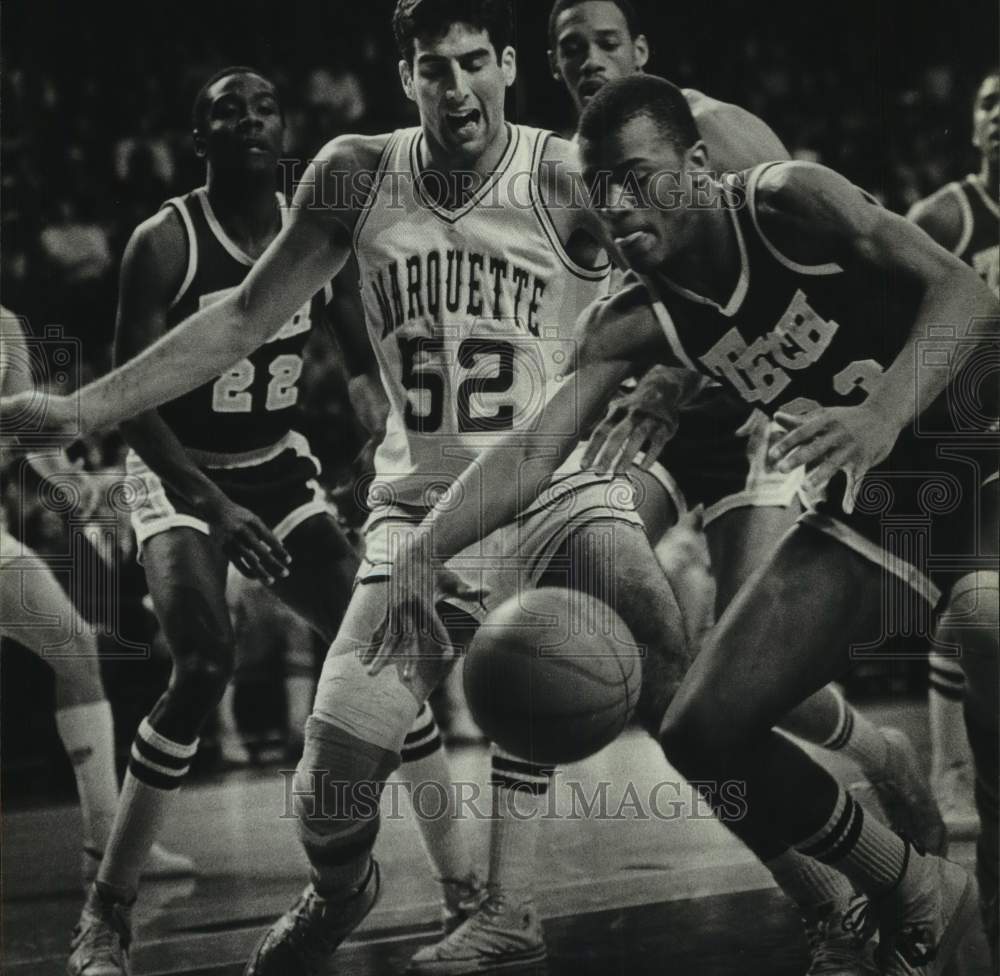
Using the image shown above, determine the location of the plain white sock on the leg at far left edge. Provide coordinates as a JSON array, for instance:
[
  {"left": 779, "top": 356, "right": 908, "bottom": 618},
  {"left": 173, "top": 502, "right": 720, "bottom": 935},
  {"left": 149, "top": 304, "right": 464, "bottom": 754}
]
[{"left": 56, "top": 699, "right": 118, "bottom": 852}]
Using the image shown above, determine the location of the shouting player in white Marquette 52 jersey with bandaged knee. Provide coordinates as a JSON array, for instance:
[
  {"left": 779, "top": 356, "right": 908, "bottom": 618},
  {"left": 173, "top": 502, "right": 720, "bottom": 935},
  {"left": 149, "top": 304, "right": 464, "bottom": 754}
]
[{"left": 0, "top": 0, "right": 688, "bottom": 976}]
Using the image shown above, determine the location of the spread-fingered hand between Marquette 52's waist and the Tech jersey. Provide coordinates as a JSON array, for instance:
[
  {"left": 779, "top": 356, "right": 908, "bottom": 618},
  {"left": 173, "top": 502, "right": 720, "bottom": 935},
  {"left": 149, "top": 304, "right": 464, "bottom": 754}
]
[{"left": 581, "top": 365, "right": 704, "bottom": 474}]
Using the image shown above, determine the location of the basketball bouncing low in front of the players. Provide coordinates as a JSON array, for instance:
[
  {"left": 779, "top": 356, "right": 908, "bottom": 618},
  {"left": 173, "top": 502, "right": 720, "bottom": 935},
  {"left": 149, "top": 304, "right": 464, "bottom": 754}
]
[{"left": 464, "top": 588, "right": 642, "bottom": 764}]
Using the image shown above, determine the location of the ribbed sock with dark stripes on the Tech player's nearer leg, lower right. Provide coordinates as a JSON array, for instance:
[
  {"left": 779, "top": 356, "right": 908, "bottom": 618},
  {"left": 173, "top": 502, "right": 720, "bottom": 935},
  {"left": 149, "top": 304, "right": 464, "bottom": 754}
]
[{"left": 795, "top": 787, "right": 907, "bottom": 896}]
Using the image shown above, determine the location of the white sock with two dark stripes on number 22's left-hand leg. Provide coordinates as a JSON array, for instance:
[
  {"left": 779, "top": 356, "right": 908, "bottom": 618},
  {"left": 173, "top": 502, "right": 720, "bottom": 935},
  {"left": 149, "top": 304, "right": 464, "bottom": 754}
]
[{"left": 97, "top": 718, "right": 198, "bottom": 898}]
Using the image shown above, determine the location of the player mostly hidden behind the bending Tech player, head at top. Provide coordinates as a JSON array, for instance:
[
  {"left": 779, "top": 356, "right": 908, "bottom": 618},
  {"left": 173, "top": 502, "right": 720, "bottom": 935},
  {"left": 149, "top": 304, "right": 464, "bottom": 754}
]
[{"left": 549, "top": 0, "right": 944, "bottom": 850}]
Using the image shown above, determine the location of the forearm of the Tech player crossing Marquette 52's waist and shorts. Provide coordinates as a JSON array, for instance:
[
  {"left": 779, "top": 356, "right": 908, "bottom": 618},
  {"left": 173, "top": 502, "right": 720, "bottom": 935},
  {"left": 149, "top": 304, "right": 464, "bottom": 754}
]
[{"left": 423, "top": 361, "right": 633, "bottom": 561}]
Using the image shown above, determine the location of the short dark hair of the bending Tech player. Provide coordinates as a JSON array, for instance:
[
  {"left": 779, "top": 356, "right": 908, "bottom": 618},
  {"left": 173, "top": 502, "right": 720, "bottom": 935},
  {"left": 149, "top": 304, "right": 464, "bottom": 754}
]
[{"left": 579, "top": 75, "right": 701, "bottom": 153}]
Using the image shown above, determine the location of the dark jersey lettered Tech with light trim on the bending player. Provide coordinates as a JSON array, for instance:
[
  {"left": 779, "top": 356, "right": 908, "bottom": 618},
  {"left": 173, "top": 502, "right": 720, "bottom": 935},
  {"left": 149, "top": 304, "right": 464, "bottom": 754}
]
[{"left": 645, "top": 164, "right": 936, "bottom": 428}]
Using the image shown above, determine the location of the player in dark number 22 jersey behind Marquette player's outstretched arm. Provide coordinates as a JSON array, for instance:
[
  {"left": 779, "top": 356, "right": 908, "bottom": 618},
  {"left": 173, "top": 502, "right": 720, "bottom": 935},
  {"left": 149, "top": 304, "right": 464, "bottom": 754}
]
[{"left": 62, "top": 67, "right": 476, "bottom": 976}]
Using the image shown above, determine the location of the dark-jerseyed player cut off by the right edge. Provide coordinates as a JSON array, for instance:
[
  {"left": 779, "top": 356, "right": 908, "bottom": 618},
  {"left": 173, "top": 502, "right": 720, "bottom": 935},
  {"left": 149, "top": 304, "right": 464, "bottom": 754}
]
[{"left": 909, "top": 69, "right": 1000, "bottom": 968}]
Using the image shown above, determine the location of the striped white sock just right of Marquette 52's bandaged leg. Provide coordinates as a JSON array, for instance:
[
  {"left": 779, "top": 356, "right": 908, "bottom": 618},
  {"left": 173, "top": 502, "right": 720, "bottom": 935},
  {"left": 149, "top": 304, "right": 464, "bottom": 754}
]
[{"left": 398, "top": 703, "right": 473, "bottom": 881}]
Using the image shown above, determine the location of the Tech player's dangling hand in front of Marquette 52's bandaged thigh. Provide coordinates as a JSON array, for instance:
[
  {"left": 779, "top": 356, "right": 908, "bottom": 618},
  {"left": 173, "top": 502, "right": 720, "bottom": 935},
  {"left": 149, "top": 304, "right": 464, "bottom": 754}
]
[{"left": 362, "top": 534, "right": 486, "bottom": 683}]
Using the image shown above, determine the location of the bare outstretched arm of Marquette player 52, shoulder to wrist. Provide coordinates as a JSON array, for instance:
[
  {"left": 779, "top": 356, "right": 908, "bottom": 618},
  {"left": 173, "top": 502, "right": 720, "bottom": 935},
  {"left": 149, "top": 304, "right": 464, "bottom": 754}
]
[{"left": 27, "top": 137, "right": 376, "bottom": 432}]
